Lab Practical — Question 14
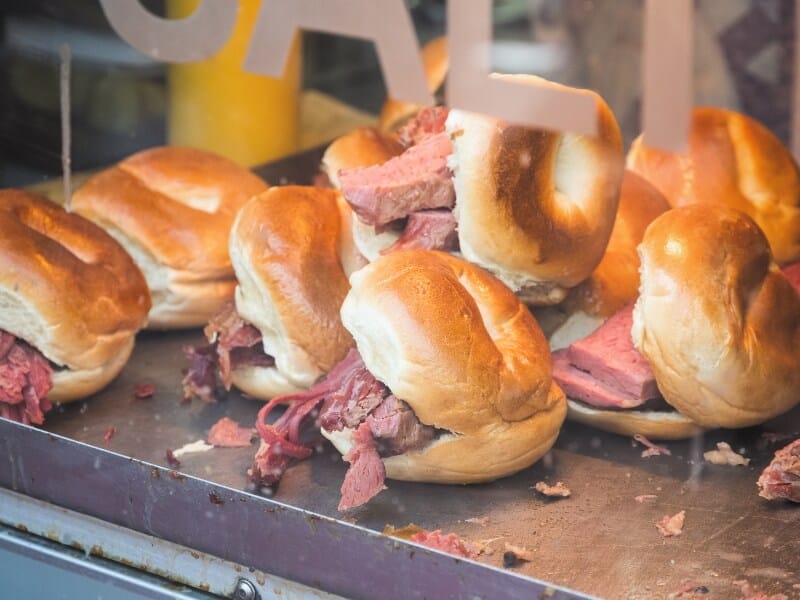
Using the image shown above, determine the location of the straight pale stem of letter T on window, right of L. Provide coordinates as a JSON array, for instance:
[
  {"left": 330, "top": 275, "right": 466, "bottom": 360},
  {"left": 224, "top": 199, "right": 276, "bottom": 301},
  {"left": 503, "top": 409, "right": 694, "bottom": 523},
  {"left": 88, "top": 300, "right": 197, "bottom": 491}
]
[{"left": 642, "top": 0, "right": 694, "bottom": 152}]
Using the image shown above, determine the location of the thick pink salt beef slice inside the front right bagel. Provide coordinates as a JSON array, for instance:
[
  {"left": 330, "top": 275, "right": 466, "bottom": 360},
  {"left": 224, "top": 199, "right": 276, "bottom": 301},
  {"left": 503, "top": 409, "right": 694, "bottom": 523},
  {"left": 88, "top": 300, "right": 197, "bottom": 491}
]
[{"left": 553, "top": 304, "right": 661, "bottom": 408}]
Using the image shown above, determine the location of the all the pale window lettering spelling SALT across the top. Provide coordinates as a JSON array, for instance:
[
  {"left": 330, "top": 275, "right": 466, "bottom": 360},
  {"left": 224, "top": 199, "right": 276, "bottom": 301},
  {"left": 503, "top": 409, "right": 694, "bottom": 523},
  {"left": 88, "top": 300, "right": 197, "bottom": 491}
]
[{"left": 100, "top": 0, "right": 800, "bottom": 156}]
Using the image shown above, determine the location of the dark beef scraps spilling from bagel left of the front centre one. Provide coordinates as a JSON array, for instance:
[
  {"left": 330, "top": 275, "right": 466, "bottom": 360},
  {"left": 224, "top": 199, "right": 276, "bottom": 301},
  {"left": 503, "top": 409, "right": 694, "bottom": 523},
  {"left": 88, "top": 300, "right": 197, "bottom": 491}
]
[{"left": 182, "top": 303, "right": 275, "bottom": 402}]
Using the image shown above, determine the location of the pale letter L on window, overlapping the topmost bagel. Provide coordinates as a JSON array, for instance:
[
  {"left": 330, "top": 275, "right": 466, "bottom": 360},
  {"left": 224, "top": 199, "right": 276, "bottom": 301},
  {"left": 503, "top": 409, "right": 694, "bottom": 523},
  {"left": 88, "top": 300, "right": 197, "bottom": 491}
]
[{"left": 447, "top": 0, "right": 597, "bottom": 135}]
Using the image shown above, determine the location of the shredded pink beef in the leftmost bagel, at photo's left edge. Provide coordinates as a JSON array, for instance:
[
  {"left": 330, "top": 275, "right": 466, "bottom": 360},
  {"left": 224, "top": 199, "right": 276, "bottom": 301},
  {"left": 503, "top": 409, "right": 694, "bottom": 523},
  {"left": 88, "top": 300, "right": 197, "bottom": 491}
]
[{"left": 0, "top": 330, "right": 53, "bottom": 425}]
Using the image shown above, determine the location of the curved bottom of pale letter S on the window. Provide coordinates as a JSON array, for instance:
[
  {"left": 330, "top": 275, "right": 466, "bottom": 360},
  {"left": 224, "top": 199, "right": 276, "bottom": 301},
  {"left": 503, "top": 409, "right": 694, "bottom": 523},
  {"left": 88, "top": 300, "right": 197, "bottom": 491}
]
[{"left": 100, "top": 0, "right": 238, "bottom": 62}]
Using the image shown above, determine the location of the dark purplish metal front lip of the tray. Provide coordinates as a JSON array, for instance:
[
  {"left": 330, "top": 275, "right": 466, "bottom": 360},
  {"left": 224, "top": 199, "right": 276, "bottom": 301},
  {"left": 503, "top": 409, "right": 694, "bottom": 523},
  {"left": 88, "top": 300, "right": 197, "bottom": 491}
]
[{"left": 0, "top": 419, "right": 587, "bottom": 600}]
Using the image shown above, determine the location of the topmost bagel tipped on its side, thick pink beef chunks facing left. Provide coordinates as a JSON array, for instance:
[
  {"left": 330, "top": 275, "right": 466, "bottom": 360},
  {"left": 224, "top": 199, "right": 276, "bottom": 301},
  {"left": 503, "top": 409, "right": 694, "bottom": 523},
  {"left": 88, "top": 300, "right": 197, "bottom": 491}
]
[{"left": 339, "top": 75, "right": 624, "bottom": 305}]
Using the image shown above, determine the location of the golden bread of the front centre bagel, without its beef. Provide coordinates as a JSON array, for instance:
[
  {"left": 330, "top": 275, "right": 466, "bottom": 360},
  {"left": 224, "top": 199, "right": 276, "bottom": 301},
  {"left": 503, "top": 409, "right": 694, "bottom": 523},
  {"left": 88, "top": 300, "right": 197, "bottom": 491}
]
[{"left": 341, "top": 250, "right": 566, "bottom": 483}]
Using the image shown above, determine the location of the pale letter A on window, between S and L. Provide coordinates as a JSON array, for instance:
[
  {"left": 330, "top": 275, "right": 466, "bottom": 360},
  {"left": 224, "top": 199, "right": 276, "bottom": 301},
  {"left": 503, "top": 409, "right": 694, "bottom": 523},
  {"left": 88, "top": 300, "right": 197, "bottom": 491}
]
[{"left": 244, "top": 0, "right": 434, "bottom": 105}]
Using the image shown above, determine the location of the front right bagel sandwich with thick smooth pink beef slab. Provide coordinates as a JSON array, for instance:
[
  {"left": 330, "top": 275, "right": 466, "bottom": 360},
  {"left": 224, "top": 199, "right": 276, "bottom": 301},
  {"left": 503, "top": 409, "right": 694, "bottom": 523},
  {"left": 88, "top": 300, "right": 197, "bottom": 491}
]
[{"left": 554, "top": 204, "right": 800, "bottom": 439}]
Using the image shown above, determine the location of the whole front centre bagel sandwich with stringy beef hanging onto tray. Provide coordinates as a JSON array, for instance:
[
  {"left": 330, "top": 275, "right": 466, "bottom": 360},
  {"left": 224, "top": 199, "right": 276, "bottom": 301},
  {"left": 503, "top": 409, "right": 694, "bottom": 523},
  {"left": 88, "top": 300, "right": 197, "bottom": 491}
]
[{"left": 250, "top": 250, "right": 566, "bottom": 510}]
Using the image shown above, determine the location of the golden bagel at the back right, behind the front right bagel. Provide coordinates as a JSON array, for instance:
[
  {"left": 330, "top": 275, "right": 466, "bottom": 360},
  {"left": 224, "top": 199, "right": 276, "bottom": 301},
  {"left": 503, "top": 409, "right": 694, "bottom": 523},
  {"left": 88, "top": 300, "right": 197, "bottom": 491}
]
[{"left": 627, "top": 107, "right": 800, "bottom": 265}]
